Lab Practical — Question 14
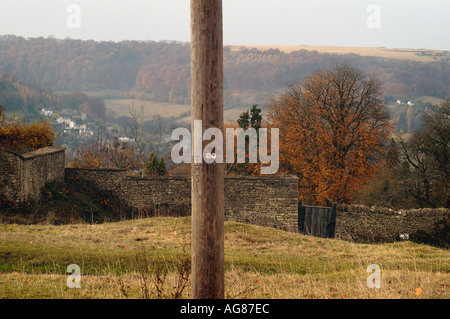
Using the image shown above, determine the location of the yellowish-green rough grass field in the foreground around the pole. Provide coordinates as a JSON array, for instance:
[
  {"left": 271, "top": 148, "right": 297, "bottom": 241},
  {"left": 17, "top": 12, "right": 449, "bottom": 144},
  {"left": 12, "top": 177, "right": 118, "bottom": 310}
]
[{"left": 0, "top": 217, "right": 450, "bottom": 299}]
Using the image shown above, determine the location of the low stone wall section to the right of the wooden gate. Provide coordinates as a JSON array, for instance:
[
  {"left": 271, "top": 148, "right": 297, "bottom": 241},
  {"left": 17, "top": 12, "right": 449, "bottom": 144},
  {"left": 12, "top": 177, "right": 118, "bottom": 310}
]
[{"left": 335, "top": 205, "right": 450, "bottom": 242}]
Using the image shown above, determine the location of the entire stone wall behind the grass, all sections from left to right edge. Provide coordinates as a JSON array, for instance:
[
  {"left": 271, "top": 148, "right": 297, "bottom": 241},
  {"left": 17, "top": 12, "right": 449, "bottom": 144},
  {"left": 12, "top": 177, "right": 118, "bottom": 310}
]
[{"left": 0, "top": 147, "right": 450, "bottom": 242}]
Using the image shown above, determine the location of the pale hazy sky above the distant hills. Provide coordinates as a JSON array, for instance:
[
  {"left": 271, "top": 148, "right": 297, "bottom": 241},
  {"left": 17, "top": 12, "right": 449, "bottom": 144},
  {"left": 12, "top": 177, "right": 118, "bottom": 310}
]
[{"left": 0, "top": 0, "right": 450, "bottom": 50}]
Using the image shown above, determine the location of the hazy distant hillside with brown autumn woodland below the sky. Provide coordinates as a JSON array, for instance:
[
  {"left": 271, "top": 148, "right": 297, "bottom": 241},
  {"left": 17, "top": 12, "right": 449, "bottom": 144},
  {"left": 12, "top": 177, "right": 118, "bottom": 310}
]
[{"left": 0, "top": 36, "right": 450, "bottom": 104}]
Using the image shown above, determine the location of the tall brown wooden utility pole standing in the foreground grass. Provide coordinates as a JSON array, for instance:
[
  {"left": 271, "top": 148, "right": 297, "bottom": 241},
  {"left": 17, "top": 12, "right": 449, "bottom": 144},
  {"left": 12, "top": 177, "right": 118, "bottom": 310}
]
[{"left": 191, "top": 0, "right": 224, "bottom": 299}]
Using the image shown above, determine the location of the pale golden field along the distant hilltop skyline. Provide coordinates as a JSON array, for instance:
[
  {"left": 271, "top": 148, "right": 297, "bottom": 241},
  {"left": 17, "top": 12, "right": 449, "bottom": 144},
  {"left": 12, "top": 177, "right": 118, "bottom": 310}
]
[{"left": 229, "top": 45, "right": 450, "bottom": 62}]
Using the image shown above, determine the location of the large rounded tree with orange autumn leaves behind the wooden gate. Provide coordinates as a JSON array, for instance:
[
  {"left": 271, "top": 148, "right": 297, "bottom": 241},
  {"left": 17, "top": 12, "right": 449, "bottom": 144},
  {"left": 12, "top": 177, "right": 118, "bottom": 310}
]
[{"left": 269, "top": 63, "right": 391, "bottom": 202}]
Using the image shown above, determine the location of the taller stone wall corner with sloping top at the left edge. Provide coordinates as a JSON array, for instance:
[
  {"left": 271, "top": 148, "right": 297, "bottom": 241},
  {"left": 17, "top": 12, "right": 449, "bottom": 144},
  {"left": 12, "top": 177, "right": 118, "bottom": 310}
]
[{"left": 0, "top": 146, "right": 65, "bottom": 202}]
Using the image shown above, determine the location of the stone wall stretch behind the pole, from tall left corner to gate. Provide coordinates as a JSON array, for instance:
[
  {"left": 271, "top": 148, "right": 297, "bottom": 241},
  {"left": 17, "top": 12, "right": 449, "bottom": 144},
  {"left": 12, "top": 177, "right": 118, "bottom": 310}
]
[{"left": 66, "top": 168, "right": 298, "bottom": 231}]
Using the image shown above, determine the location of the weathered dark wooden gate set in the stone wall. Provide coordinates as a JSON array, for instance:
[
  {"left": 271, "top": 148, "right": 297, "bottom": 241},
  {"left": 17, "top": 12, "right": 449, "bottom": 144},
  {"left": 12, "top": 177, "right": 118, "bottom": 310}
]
[{"left": 298, "top": 196, "right": 336, "bottom": 238}]
